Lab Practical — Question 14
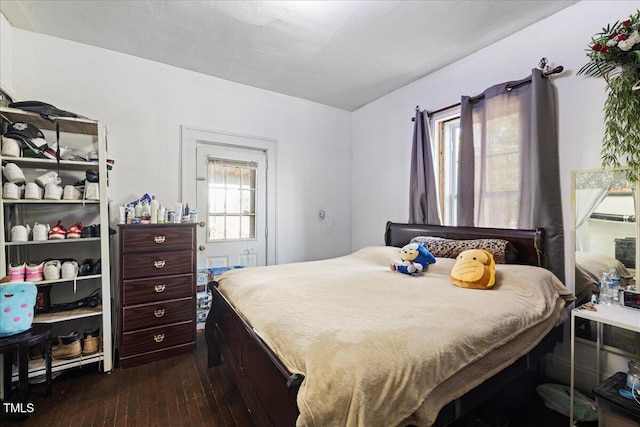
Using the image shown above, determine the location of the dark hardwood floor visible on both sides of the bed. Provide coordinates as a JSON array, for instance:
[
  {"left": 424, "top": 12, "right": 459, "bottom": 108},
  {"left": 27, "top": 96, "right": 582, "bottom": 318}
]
[{"left": 0, "top": 334, "right": 597, "bottom": 427}]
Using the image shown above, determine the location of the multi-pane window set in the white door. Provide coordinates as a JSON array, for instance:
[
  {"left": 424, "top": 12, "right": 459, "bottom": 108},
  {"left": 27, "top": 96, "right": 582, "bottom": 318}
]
[{"left": 207, "top": 158, "right": 258, "bottom": 242}]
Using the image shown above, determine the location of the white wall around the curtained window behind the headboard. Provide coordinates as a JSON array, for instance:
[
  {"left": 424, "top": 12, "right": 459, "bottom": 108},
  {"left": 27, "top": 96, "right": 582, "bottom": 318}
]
[{"left": 351, "top": 1, "right": 638, "bottom": 387}]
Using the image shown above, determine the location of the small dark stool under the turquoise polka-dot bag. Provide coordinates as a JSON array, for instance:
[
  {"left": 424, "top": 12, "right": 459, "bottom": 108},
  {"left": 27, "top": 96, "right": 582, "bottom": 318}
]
[{"left": 0, "top": 323, "right": 51, "bottom": 401}]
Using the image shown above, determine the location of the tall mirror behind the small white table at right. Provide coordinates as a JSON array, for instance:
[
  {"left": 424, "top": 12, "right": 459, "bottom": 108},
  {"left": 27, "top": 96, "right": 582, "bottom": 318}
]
[{"left": 571, "top": 169, "right": 640, "bottom": 357}]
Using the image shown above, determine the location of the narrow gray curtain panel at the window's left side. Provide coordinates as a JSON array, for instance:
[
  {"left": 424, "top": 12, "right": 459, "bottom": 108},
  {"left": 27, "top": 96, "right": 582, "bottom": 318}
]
[{"left": 409, "top": 110, "right": 441, "bottom": 225}]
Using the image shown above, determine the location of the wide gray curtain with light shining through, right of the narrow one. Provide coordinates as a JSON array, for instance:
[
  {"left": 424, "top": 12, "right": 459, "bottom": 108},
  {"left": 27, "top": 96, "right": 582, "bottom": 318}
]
[{"left": 458, "top": 69, "right": 564, "bottom": 281}]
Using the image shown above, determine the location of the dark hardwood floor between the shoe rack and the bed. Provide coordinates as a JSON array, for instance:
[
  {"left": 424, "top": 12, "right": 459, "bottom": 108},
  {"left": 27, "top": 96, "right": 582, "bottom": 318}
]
[{"left": 0, "top": 334, "right": 254, "bottom": 427}]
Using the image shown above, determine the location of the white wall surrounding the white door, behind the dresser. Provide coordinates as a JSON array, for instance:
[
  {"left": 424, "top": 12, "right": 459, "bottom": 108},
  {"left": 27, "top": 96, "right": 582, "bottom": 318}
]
[{"left": 2, "top": 21, "right": 351, "bottom": 263}]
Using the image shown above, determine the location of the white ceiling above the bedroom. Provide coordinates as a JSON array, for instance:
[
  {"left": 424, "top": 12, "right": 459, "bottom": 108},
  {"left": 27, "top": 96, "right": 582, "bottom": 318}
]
[{"left": 0, "top": 0, "right": 576, "bottom": 111}]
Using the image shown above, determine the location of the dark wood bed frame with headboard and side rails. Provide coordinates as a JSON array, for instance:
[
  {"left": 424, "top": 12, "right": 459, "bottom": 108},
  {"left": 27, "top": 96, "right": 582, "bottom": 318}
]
[{"left": 205, "top": 222, "right": 562, "bottom": 427}]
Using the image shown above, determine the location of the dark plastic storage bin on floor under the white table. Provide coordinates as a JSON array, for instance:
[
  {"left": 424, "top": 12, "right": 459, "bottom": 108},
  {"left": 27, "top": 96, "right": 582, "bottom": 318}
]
[{"left": 593, "top": 372, "right": 640, "bottom": 427}]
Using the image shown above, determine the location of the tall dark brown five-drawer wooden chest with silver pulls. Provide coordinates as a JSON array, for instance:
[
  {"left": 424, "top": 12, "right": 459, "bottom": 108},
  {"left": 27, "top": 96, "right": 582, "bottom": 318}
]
[{"left": 118, "top": 224, "right": 196, "bottom": 368}]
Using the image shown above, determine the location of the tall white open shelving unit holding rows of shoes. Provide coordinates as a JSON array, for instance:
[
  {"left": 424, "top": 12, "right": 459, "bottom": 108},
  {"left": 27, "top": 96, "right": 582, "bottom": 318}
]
[{"left": 0, "top": 107, "right": 114, "bottom": 384}]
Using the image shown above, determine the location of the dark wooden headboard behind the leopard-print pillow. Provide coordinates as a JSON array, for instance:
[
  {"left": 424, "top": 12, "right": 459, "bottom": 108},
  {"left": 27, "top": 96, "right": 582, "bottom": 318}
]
[{"left": 384, "top": 221, "right": 546, "bottom": 267}]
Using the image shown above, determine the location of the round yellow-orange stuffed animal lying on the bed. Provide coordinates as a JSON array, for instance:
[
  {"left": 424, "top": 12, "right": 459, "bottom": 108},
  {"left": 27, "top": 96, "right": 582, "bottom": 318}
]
[{"left": 451, "top": 249, "right": 496, "bottom": 289}]
